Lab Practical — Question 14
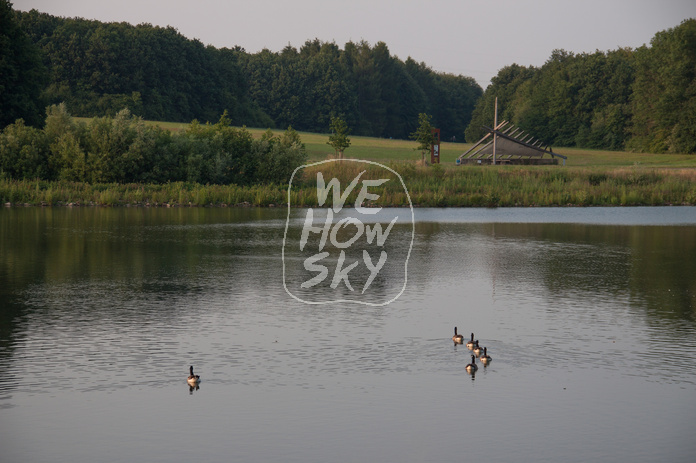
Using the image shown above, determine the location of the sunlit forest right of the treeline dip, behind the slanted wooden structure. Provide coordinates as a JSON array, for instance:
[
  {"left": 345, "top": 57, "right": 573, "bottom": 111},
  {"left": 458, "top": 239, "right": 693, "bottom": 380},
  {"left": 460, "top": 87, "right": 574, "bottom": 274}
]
[{"left": 466, "top": 19, "right": 696, "bottom": 153}]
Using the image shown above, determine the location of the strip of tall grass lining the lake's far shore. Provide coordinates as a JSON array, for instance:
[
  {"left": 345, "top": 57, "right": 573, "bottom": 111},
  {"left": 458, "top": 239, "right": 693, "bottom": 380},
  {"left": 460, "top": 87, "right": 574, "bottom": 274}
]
[{"left": 0, "top": 161, "right": 696, "bottom": 207}]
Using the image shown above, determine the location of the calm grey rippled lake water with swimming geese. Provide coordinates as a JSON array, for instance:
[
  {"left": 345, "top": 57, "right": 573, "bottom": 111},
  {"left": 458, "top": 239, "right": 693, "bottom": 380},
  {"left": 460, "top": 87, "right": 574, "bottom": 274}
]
[{"left": 0, "top": 207, "right": 696, "bottom": 463}]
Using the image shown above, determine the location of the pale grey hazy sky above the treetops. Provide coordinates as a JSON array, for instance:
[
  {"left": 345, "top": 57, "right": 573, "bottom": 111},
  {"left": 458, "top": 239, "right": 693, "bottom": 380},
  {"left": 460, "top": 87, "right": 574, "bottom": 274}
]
[{"left": 11, "top": 0, "right": 696, "bottom": 89}]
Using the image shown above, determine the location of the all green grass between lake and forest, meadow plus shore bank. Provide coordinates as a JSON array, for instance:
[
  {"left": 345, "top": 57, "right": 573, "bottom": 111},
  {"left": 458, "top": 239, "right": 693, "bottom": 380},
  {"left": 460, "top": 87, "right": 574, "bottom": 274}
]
[{"left": 6, "top": 118, "right": 696, "bottom": 207}]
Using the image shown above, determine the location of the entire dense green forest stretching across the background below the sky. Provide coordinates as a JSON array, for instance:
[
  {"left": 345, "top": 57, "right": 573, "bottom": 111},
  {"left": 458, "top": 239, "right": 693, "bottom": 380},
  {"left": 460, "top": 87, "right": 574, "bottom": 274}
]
[{"left": 0, "top": 0, "right": 696, "bottom": 165}]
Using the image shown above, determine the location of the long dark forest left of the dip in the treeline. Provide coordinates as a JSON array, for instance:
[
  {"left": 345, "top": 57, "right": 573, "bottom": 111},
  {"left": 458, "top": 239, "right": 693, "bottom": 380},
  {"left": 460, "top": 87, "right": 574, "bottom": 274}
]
[{"left": 5, "top": 4, "right": 482, "bottom": 140}]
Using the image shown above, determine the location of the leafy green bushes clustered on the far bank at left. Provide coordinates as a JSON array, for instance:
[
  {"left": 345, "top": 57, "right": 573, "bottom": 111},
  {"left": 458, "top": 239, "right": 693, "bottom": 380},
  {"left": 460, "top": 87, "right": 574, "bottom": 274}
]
[{"left": 0, "top": 103, "right": 307, "bottom": 185}]
